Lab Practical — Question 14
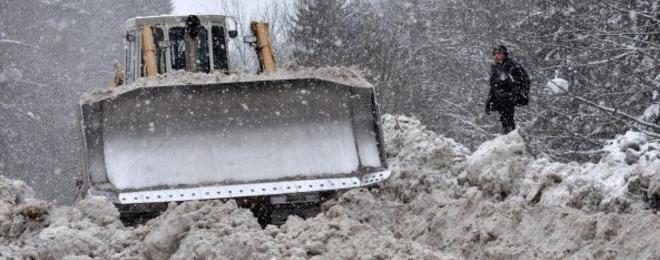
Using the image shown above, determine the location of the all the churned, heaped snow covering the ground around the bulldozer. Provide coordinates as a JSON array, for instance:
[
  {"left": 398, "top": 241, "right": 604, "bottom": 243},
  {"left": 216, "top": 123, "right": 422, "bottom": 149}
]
[{"left": 0, "top": 115, "right": 660, "bottom": 259}]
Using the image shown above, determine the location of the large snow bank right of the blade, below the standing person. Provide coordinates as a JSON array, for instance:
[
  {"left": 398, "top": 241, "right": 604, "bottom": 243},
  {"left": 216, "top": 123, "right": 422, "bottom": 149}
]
[{"left": 332, "top": 115, "right": 660, "bottom": 259}]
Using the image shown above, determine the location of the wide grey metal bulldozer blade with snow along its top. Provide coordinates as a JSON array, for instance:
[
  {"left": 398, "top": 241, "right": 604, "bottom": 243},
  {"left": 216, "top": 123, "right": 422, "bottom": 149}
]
[{"left": 81, "top": 78, "right": 390, "bottom": 204}]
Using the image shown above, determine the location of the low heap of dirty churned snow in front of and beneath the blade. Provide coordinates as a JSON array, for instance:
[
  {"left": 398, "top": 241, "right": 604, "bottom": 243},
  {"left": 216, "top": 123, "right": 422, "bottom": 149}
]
[{"left": 0, "top": 178, "right": 455, "bottom": 259}]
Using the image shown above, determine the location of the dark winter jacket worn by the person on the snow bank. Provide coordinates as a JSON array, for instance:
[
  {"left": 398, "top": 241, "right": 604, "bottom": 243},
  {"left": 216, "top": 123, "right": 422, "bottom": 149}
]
[{"left": 486, "top": 57, "right": 529, "bottom": 111}]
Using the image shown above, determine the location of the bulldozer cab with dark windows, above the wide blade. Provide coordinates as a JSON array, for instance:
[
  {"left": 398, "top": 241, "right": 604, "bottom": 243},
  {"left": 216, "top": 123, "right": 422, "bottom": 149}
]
[{"left": 124, "top": 15, "right": 236, "bottom": 83}]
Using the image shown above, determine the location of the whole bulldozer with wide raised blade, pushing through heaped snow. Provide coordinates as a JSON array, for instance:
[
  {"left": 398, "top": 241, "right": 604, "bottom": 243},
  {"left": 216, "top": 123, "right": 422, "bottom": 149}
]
[{"left": 79, "top": 15, "right": 390, "bottom": 223}]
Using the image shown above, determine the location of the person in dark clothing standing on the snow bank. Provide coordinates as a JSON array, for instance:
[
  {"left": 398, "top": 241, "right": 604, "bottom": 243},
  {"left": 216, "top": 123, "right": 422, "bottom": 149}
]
[{"left": 486, "top": 45, "right": 530, "bottom": 134}]
